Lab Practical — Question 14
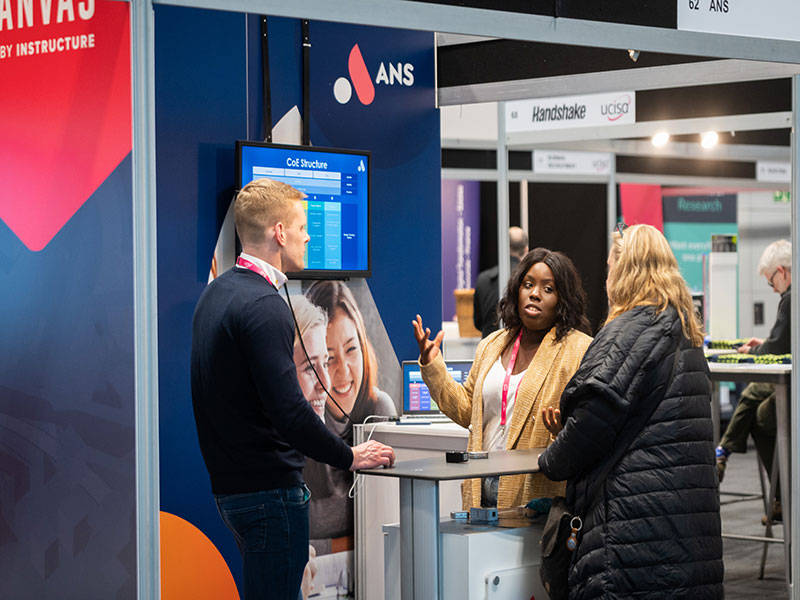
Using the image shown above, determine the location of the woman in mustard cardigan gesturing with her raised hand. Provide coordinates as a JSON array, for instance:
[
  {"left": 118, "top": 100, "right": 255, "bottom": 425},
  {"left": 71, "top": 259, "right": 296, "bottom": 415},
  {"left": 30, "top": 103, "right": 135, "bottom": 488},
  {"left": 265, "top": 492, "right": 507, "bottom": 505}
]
[{"left": 413, "top": 248, "right": 592, "bottom": 509}]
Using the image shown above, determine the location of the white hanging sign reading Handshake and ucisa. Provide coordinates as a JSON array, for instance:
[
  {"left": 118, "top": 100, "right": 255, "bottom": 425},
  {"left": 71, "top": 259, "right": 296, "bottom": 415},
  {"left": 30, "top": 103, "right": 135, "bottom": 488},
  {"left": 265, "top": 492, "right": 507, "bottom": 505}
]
[{"left": 506, "top": 92, "right": 636, "bottom": 133}]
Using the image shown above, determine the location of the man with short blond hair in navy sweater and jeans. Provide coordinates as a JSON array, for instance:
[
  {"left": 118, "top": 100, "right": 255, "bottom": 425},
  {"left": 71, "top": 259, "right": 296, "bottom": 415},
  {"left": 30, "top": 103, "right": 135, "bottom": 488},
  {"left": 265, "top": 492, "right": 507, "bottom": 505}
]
[{"left": 191, "top": 179, "right": 394, "bottom": 600}]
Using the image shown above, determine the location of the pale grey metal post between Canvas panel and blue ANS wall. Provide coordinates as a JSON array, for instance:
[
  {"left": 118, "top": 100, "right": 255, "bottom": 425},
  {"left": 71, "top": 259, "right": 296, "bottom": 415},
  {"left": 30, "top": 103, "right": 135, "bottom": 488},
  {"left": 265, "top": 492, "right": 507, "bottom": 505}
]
[{"left": 130, "top": 0, "right": 161, "bottom": 600}]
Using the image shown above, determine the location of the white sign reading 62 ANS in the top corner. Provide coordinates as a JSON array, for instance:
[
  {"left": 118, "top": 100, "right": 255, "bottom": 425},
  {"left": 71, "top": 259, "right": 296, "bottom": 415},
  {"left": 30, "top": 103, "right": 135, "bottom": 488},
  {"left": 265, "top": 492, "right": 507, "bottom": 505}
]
[{"left": 677, "top": 0, "right": 800, "bottom": 42}]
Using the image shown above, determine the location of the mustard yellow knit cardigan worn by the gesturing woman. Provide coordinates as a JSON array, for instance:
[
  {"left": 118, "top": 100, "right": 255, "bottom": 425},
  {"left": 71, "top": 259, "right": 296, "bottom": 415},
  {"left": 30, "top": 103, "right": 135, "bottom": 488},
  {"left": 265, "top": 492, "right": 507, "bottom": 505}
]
[{"left": 421, "top": 327, "right": 592, "bottom": 510}]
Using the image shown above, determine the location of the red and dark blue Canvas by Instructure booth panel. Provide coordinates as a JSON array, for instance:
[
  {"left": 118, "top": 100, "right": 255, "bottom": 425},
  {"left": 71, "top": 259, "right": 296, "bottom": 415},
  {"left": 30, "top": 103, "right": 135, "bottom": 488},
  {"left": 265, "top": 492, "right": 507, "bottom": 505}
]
[{"left": 0, "top": 2, "right": 137, "bottom": 598}]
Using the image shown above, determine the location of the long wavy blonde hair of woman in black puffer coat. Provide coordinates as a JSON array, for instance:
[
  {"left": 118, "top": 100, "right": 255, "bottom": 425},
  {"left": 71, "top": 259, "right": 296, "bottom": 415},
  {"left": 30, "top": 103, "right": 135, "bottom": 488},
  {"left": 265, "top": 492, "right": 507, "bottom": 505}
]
[{"left": 606, "top": 225, "right": 703, "bottom": 346}]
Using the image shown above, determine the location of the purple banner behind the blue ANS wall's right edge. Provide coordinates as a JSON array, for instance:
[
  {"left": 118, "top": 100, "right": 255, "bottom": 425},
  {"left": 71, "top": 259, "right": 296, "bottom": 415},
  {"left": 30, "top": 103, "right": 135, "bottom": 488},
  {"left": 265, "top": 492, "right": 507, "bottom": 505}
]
[{"left": 442, "top": 179, "right": 481, "bottom": 321}]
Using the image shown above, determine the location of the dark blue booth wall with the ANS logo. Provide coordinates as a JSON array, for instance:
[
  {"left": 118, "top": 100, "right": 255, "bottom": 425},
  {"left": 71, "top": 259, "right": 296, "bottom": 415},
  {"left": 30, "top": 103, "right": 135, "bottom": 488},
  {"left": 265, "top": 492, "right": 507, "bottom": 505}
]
[{"left": 155, "top": 6, "right": 442, "bottom": 598}]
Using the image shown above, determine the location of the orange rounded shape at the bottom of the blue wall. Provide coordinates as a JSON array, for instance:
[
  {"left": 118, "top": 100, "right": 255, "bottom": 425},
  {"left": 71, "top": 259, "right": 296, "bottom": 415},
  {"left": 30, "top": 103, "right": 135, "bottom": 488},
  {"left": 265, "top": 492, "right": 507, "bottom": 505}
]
[{"left": 161, "top": 511, "right": 239, "bottom": 600}]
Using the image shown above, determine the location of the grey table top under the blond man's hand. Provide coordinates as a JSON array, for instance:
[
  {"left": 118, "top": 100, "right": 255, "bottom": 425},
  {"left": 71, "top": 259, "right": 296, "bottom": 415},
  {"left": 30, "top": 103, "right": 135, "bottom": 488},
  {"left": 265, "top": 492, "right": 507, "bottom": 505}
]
[{"left": 359, "top": 448, "right": 544, "bottom": 481}]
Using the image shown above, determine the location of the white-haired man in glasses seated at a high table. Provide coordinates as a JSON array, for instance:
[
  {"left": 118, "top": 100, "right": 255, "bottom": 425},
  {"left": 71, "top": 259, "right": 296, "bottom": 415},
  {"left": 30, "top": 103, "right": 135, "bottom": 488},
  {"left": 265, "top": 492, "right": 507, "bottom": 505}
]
[{"left": 717, "top": 240, "right": 792, "bottom": 519}]
